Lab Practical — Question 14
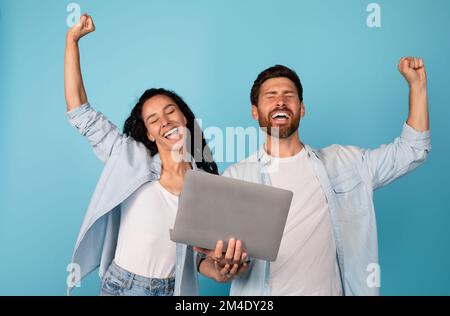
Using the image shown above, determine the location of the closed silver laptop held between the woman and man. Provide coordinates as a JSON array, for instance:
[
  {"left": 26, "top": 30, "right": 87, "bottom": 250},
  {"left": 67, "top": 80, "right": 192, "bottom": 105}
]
[{"left": 170, "top": 171, "right": 293, "bottom": 261}]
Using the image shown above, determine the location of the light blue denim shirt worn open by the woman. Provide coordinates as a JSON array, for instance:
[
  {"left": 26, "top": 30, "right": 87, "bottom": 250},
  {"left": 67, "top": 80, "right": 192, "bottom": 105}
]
[{"left": 66, "top": 104, "right": 198, "bottom": 296}]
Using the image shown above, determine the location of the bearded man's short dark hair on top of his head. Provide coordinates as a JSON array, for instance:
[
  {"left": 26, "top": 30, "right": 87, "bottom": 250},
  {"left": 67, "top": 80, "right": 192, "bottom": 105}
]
[{"left": 250, "top": 65, "right": 303, "bottom": 105}]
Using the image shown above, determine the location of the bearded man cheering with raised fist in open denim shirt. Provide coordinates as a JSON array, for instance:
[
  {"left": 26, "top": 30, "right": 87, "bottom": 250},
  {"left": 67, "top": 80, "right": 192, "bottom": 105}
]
[{"left": 200, "top": 58, "right": 431, "bottom": 295}]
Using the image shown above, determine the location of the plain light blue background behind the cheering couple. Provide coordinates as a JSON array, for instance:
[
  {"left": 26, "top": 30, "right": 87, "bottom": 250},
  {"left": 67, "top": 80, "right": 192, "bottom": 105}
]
[{"left": 0, "top": 0, "right": 450, "bottom": 295}]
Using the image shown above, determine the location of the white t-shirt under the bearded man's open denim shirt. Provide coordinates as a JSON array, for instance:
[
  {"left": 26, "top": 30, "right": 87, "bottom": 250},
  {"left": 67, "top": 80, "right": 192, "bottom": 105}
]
[{"left": 269, "top": 149, "right": 342, "bottom": 295}]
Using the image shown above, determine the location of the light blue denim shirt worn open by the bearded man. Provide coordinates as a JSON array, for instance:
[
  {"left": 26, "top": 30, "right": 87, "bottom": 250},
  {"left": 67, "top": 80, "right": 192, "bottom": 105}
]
[{"left": 223, "top": 124, "right": 431, "bottom": 296}]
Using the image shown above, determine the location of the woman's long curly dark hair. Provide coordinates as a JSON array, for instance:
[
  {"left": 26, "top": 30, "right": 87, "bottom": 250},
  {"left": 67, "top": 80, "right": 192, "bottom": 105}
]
[{"left": 123, "top": 88, "right": 218, "bottom": 174}]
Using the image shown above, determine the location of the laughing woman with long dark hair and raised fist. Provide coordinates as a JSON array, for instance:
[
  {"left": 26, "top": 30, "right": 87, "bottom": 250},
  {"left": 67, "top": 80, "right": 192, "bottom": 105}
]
[{"left": 64, "top": 14, "right": 245, "bottom": 296}]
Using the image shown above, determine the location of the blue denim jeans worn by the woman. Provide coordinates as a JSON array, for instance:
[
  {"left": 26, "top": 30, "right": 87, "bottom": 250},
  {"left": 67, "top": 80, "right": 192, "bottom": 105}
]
[{"left": 100, "top": 262, "right": 175, "bottom": 296}]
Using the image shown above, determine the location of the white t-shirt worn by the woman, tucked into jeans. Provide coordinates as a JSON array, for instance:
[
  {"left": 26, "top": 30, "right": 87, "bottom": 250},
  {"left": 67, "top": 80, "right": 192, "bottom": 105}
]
[{"left": 114, "top": 181, "right": 178, "bottom": 278}]
